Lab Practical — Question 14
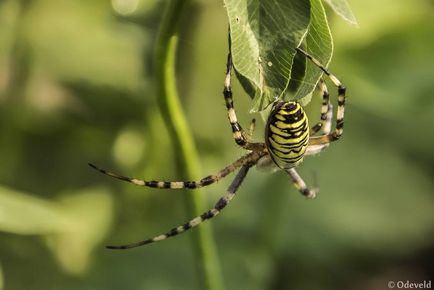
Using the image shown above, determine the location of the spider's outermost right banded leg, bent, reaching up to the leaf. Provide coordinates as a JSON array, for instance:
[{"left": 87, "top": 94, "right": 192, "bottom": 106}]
[{"left": 296, "top": 48, "right": 346, "bottom": 145}]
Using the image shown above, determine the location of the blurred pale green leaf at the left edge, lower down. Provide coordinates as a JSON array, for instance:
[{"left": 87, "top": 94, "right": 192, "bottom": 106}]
[{"left": 0, "top": 186, "right": 113, "bottom": 276}]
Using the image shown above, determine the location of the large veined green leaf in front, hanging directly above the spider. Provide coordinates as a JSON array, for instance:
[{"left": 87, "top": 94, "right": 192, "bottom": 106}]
[{"left": 225, "top": 0, "right": 310, "bottom": 112}]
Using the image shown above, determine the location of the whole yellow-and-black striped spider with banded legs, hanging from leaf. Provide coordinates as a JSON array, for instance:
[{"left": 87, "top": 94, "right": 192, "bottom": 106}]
[{"left": 89, "top": 48, "right": 346, "bottom": 249}]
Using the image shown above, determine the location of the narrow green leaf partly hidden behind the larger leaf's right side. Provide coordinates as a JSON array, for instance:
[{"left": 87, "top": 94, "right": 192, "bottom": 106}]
[{"left": 294, "top": 0, "right": 333, "bottom": 105}]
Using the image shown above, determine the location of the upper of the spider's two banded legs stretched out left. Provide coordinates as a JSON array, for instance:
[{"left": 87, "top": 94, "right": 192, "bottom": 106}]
[{"left": 89, "top": 152, "right": 255, "bottom": 189}]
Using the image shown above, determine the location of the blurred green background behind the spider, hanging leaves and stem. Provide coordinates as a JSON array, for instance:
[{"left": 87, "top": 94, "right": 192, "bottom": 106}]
[{"left": 0, "top": 0, "right": 434, "bottom": 290}]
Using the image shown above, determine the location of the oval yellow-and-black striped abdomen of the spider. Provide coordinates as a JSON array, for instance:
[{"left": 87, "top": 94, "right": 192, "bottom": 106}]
[{"left": 265, "top": 102, "right": 309, "bottom": 169}]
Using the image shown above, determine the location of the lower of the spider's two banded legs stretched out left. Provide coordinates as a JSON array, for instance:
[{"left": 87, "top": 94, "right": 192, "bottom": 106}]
[{"left": 107, "top": 162, "right": 254, "bottom": 250}]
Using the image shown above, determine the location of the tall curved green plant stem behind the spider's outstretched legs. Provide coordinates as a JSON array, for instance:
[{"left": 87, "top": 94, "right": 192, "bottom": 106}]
[{"left": 154, "top": 0, "right": 223, "bottom": 290}]
